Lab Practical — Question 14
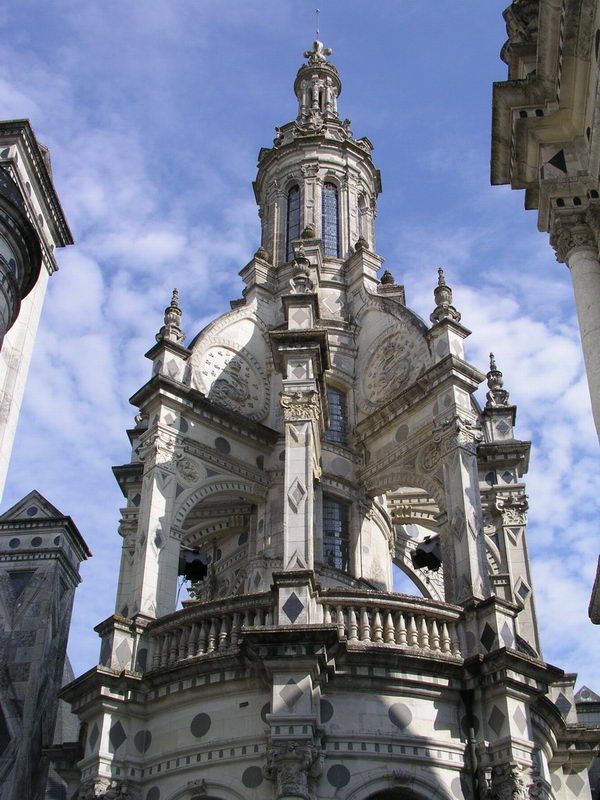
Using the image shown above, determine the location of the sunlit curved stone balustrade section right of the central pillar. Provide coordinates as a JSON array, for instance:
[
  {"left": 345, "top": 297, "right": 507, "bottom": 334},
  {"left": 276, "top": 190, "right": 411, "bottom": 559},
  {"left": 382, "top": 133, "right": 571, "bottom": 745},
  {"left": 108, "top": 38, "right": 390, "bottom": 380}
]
[{"left": 319, "top": 589, "right": 461, "bottom": 658}]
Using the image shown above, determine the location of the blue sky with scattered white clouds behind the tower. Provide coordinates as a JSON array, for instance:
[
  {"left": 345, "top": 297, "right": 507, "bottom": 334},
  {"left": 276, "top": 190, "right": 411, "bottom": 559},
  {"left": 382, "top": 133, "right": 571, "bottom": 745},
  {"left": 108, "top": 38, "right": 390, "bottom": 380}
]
[{"left": 0, "top": 0, "right": 600, "bottom": 691}]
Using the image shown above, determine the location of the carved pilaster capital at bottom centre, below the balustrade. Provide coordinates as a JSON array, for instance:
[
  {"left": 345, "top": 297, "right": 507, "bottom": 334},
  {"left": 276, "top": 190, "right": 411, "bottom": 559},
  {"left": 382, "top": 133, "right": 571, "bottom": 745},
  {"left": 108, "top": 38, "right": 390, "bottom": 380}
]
[{"left": 265, "top": 742, "right": 322, "bottom": 800}]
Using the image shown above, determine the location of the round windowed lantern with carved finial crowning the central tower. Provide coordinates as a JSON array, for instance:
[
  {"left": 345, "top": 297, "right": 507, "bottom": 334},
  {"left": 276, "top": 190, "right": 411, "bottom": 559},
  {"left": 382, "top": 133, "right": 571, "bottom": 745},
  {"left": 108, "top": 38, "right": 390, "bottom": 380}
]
[{"left": 254, "top": 39, "right": 381, "bottom": 266}]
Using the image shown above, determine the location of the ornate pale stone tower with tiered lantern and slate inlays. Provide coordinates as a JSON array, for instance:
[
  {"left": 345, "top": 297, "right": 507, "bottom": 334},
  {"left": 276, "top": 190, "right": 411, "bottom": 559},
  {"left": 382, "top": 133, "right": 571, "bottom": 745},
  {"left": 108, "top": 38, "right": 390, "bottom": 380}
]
[{"left": 63, "top": 41, "right": 597, "bottom": 800}]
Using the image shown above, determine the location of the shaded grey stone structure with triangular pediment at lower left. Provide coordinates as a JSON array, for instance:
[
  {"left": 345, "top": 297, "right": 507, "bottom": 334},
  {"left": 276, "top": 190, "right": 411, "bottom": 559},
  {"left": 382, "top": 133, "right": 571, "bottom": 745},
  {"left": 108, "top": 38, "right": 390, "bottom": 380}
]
[{"left": 0, "top": 491, "right": 90, "bottom": 800}]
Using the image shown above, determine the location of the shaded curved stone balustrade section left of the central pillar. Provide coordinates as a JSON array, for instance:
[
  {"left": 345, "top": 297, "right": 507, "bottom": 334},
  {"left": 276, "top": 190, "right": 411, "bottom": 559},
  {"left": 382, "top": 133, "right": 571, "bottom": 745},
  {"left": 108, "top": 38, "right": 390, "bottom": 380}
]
[{"left": 148, "top": 592, "right": 276, "bottom": 669}]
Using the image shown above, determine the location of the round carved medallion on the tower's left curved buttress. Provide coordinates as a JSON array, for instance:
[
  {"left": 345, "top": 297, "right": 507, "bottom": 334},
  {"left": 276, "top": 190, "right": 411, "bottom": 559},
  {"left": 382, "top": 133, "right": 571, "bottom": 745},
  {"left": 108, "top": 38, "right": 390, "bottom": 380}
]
[{"left": 192, "top": 342, "right": 269, "bottom": 420}]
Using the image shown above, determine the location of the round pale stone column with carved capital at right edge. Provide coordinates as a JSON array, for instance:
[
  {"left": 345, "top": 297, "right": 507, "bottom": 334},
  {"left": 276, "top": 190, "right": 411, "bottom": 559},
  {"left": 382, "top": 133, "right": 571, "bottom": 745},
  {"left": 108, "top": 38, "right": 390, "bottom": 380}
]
[{"left": 550, "top": 213, "right": 600, "bottom": 436}]
